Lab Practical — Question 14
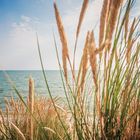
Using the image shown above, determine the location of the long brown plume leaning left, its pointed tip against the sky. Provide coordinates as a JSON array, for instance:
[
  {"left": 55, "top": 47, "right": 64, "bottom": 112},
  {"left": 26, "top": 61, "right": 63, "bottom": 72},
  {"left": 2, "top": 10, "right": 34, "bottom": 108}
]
[{"left": 54, "top": 2, "right": 72, "bottom": 81}]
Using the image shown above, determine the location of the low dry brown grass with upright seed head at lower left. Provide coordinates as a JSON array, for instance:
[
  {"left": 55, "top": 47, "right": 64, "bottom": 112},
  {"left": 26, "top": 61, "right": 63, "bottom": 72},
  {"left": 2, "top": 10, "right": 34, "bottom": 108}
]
[{"left": 0, "top": 78, "right": 68, "bottom": 140}]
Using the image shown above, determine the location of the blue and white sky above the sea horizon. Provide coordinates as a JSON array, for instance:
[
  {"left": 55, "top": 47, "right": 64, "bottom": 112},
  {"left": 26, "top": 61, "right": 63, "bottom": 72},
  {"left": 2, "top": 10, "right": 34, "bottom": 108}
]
[{"left": 0, "top": 0, "right": 140, "bottom": 70}]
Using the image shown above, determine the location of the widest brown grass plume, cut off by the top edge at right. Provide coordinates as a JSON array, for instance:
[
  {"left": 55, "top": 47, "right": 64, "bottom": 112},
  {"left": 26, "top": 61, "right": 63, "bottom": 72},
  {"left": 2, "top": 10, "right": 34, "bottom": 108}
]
[{"left": 107, "top": 0, "right": 123, "bottom": 50}]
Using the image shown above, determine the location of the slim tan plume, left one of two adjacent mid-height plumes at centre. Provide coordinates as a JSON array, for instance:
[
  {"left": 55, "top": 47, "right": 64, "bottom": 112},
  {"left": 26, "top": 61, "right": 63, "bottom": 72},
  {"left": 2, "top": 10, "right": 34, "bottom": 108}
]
[{"left": 80, "top": 31, "right": 89, "bottom": 92}]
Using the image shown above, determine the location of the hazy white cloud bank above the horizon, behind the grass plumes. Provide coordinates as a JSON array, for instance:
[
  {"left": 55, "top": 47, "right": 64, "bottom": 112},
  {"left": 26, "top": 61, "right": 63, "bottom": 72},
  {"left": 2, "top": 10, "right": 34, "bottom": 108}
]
[{"left": 0, "top": 0, "right": 102, "bottom": 69}]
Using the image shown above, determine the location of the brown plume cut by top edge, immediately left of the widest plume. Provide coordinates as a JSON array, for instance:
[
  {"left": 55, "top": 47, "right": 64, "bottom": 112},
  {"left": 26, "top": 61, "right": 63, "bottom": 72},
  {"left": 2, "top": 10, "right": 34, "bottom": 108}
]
[{"left": 99, "top": 0, "right": 110, "bottom": 48}]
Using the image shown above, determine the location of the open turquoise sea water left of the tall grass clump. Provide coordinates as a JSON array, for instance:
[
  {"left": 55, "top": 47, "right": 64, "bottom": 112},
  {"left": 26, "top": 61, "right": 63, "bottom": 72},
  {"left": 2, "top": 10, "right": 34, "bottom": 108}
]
[{"left": 0, "top": 70, "right": 64, "bottom": 108}]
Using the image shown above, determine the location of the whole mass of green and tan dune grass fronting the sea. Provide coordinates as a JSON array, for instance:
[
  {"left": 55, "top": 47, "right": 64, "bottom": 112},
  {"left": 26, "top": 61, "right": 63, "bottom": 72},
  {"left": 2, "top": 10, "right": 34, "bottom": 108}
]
[{"left": 0, "top": 0, "right": 140, "bottom": 140}]
